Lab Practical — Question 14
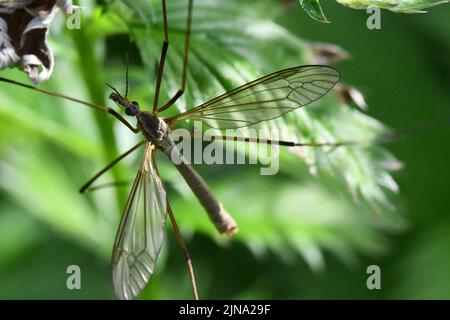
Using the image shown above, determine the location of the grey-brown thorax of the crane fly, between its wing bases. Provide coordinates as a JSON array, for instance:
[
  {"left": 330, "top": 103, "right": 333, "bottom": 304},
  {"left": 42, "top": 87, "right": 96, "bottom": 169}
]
[{"left": 136, "top": 112, "right": 175, "bottom": 153}]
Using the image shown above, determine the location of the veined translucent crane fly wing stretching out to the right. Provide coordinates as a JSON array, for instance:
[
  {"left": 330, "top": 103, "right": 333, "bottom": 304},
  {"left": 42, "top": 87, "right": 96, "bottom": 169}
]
[{"left": 166, "top": 65, "right": 340, "bottom": 129}]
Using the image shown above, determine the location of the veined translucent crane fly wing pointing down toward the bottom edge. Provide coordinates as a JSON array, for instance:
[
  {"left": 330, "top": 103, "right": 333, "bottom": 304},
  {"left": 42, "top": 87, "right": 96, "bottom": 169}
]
[{"left": 112, "top": 143, "right": 167, "bottom": 300}]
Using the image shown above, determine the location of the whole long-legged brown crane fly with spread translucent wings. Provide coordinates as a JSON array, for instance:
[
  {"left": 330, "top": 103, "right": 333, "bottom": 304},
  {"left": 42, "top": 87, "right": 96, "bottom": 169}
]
[{"left": 0, "top": 0, "right": 340, "bottom": 299}]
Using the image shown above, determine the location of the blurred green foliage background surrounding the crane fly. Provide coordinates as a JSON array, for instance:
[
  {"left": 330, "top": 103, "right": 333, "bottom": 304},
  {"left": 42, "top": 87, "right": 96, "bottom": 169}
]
[{"left": 0, "top": 0, "right": 450, "bottom": 299}]
